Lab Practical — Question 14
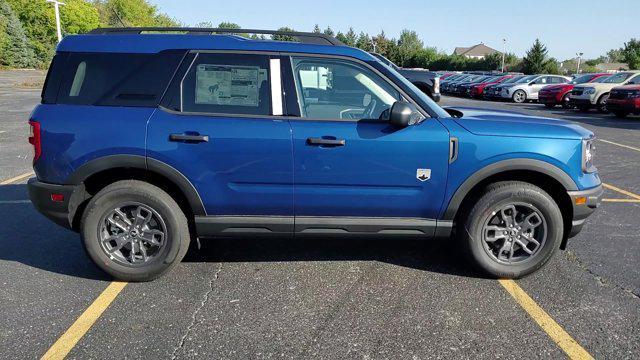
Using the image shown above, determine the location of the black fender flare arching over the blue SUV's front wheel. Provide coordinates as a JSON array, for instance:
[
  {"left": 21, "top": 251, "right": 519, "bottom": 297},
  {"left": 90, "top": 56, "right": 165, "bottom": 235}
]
[{"left": 442, "top": 158, "right": 578, "bottom": 220}]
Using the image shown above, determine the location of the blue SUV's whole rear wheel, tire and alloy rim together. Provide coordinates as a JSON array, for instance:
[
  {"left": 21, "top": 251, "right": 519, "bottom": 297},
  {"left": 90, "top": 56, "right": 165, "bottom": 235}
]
[{"left": 80, "top": 180, "right": 190, "bottom": 282}]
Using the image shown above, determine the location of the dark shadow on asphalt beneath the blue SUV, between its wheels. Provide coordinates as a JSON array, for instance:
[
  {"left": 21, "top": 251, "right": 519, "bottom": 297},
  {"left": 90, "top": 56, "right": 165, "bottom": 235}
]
[{"left": 183, "top": 233, "right": 482, "bottom": 277}]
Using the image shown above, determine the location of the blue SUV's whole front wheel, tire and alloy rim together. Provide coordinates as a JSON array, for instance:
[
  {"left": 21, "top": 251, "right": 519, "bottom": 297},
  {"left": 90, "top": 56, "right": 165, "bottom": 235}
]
[{"left": 457, "top": 181, "right": 564, "bottom": 278}]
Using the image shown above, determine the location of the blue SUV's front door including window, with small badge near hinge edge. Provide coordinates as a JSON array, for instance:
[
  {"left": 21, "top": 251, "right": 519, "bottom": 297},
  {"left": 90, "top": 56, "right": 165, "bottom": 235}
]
[{"left": 290, "top": 57, "right": 449, "bottom": 228}]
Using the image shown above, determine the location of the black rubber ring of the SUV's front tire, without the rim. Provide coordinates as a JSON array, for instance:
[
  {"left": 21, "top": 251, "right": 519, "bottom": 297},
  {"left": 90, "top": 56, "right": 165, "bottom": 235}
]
[{"left": 465, "top": 186, "right": 564, "bottom": 278}]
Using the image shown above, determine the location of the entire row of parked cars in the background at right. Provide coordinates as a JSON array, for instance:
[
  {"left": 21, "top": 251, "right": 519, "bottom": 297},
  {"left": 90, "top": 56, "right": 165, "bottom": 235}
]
[{"left": 440, "top": 71, "right": 640, "bottom": 117}]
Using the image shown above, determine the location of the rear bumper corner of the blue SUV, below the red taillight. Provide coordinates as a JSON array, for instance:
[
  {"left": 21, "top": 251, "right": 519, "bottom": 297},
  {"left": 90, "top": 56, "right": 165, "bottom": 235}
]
[{"left": 27, "top": 178, "right": 88, "bottom": 229}]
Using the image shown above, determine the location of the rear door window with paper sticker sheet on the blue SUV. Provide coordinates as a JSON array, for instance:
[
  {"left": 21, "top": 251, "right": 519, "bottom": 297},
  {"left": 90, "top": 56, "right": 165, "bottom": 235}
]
[{"left": 181, "top": 53, "right": 271, "bottom": 115}]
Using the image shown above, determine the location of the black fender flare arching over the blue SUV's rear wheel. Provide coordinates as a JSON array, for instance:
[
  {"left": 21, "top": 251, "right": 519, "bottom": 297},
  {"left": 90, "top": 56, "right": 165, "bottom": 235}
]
[{"left": 67, "top": 155, "right": 207, "bottom": 216}]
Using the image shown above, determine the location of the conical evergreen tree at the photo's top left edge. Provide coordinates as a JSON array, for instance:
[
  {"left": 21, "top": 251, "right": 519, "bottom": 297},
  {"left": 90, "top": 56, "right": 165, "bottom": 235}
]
[{"left": 0, "top": 0, "right": 36, "bottom": 68}]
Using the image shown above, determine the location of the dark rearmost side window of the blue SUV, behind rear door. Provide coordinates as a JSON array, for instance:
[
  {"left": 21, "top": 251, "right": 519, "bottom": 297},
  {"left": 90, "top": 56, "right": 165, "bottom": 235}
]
[{"left": 53, "top": 51, "right": 184, "bottom": 106}]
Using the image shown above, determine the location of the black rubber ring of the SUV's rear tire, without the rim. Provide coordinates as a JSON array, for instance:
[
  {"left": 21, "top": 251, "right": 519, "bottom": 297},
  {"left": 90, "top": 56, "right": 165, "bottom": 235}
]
[{"left": 81, "top": 183, "right": 189, "bottom": 281}]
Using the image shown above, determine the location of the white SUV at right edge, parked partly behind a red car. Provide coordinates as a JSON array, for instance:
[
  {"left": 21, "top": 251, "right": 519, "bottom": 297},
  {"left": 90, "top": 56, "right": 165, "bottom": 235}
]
[{"left": 569, "top": 71, "right": 640, "bottom": 113}]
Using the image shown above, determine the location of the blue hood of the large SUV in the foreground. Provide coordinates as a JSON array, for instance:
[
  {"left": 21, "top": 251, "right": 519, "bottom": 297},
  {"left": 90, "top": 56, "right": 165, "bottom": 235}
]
[{"left": 453, "top": 107, "right": 593, "bottom": 140}]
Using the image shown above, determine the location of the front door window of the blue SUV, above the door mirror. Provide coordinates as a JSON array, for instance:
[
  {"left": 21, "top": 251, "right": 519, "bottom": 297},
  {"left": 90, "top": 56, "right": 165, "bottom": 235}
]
[{"left": 292, "top": 57, "right": 401, "bottom": 120}]
